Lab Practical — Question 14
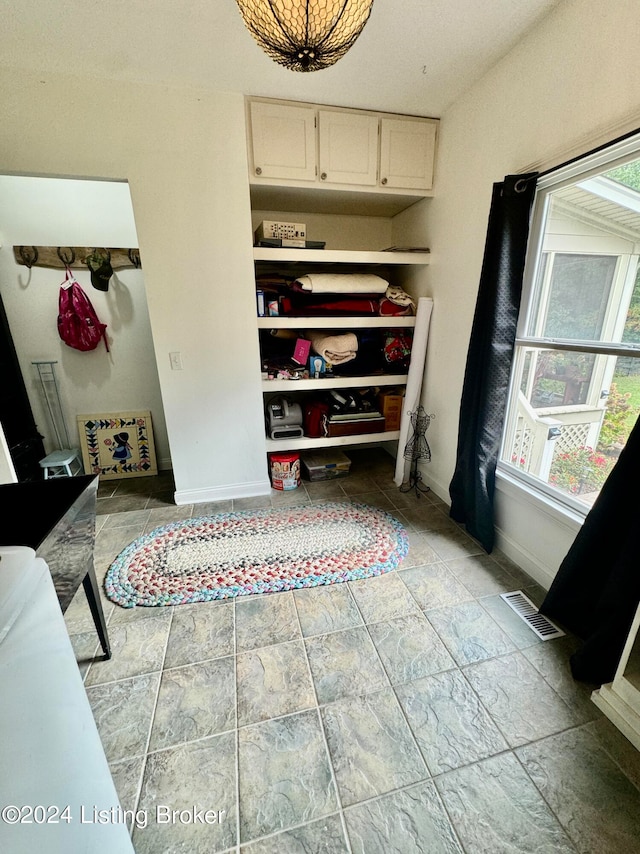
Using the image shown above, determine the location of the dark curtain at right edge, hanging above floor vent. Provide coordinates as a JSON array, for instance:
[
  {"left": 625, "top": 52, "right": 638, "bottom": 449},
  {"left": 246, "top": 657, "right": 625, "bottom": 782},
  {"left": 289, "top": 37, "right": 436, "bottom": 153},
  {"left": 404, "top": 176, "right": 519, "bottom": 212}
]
[{"left": 540, "top": 412, "right": 640, "bottom": 685}]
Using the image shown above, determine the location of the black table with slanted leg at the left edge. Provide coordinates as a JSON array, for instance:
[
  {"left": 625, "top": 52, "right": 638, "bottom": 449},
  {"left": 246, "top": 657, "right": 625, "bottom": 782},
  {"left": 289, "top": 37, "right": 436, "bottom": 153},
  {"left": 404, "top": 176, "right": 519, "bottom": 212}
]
[{"left": 0, "top": 475, "right": 111, "bottom": 658}]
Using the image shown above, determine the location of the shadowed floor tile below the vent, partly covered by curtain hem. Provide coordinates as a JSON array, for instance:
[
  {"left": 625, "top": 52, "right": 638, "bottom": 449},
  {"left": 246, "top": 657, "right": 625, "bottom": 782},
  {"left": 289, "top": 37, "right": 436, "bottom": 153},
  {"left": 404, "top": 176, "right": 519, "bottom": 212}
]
[{"left": 522, "top": 637, "right": 602, "bottom": 723}]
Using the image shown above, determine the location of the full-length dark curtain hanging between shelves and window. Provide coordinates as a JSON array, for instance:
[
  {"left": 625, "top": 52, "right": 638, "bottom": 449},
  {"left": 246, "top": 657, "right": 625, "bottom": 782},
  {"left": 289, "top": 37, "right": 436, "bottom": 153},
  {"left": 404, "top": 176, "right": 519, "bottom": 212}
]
[{"left": 449, "top": 173, "right": 537, "bottom": 552}]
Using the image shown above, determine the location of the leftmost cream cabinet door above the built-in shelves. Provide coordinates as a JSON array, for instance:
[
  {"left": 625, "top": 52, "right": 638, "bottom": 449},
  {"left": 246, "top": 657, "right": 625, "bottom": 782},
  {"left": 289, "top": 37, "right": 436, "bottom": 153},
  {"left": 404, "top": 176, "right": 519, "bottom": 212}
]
[{"left": 251, "top": 101, "right": 316, "bottom": 181}]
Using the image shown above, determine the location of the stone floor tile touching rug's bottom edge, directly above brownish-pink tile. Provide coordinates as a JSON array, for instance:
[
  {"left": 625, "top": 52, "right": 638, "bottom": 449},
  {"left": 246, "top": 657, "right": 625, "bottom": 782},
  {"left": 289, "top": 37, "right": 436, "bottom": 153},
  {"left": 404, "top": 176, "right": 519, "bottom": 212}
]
[{"left": 236, "top": 592, "right": 301, "bottom": 652}]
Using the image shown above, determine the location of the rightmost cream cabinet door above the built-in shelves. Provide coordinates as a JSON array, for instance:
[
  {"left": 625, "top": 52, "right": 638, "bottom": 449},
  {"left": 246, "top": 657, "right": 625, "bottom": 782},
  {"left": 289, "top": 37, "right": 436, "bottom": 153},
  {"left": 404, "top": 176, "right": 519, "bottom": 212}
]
[{"left": 380, "top": 119, "right": 436, "bottom": 190}]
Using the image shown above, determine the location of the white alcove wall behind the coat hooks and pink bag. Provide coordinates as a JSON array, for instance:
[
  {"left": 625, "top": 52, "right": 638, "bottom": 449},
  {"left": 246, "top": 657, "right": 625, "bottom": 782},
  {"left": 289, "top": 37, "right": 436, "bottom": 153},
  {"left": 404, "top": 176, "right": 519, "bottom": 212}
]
[{"left": 0, "top": 175, "right": 171, "bottom": 468}]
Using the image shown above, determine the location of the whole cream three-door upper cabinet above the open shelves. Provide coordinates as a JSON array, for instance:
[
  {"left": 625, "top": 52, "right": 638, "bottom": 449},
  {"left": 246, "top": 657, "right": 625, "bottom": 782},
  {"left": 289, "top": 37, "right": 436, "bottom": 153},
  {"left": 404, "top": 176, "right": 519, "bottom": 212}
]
[{"left": 247, "top": 98, "right": 439, "bottom": 210}]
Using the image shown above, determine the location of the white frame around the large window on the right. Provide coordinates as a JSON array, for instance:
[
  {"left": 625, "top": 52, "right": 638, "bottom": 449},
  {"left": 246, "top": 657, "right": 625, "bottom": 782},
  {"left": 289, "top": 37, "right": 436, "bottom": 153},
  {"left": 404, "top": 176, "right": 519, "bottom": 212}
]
[{"left": 496, "top": 133, "right": 640, "bottom": 519}]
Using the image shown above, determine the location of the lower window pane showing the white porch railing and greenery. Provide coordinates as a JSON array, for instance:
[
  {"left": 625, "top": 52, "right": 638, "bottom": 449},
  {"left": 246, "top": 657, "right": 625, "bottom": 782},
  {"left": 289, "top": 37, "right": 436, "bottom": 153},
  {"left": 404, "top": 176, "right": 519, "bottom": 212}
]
[{"left": 503, "top": 348, "right": 640, "bottom": 507}]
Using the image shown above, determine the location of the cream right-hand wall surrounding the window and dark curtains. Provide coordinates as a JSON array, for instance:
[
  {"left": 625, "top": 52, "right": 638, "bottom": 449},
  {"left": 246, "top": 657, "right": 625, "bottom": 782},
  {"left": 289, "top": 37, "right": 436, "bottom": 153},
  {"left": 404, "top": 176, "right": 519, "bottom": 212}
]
[{"left": 422, "top": 0, "right": 640, "bottom": 584}]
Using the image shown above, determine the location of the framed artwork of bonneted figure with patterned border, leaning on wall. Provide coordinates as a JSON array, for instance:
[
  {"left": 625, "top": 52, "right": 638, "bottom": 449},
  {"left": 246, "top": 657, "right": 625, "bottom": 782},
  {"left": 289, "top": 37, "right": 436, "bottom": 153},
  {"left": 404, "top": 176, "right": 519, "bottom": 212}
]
[{"left": 78, "top": 412, "right": 158, "bottom": 479}]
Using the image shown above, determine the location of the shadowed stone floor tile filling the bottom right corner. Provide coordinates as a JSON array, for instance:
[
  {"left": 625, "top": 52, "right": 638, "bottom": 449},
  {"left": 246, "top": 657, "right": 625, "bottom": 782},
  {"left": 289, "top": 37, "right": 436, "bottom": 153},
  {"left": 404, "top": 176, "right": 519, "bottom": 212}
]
[{"left": 516, "top": 728, "right": 640, "bottom": 854}]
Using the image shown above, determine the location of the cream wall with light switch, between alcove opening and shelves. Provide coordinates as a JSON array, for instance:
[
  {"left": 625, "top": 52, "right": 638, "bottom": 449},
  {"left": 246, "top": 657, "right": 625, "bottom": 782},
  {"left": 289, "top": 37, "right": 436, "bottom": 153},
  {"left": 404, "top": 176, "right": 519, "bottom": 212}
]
[{"left": 0, "top": 70, "right": 269, "bottom": 503}]
